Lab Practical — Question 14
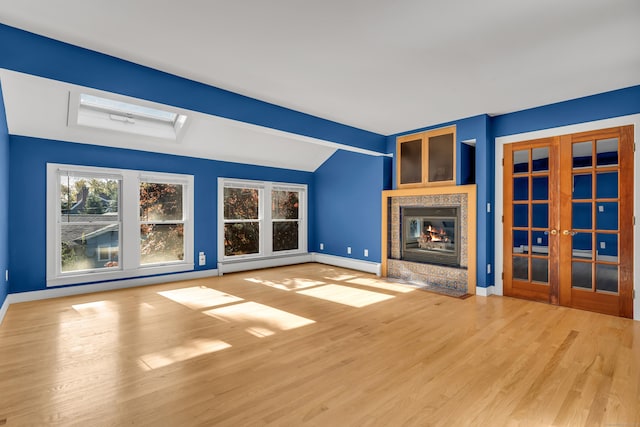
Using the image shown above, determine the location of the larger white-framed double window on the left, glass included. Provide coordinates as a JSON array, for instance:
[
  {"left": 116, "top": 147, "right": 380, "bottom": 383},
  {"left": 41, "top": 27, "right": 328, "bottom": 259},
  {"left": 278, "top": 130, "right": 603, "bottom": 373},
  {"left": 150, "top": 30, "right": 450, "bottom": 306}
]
[{"left": 47, "top": 164, "right": 193, "bottom": 286}]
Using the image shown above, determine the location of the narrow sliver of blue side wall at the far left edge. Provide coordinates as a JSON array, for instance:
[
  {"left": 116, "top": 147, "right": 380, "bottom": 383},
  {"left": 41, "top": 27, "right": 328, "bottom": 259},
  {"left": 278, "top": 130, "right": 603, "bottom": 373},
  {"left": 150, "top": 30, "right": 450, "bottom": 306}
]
[{"left": 0, "top": 84, "right": 9, "bottom": 307}]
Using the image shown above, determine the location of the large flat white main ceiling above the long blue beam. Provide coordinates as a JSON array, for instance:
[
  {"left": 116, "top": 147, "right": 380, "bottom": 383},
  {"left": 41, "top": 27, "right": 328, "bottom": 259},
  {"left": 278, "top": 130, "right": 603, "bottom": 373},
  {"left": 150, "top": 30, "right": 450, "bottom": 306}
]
[{"left": 0, "top": 0, "right": 640, "bottom": 135}]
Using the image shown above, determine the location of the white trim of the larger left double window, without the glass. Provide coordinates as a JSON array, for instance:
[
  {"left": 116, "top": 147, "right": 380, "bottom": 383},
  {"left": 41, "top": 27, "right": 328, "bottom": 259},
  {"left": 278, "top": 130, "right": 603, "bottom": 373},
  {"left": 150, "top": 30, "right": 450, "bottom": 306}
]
[{"left": 46, "top": 163, "right": 194, "bottom": 287}]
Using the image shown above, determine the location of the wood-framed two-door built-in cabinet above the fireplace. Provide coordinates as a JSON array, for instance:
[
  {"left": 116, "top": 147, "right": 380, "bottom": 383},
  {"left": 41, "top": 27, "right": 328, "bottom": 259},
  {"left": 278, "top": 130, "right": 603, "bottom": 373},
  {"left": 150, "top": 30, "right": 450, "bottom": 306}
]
[{"left": 396, "top": 126, "right": 456, "bottom": 188}]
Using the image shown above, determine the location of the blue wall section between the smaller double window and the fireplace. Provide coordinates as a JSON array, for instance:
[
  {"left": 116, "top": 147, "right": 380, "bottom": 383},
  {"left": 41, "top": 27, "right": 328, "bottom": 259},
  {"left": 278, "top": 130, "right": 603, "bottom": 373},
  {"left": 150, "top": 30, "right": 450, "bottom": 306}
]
[{"left": 309, "top": 150, "right": 391, "bottom": 262}]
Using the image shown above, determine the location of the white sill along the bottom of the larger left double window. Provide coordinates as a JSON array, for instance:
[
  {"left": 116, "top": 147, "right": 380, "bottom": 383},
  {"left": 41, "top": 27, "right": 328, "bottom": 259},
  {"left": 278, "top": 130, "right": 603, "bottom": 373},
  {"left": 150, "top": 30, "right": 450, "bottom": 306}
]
[{"left": 47, "top": 263, "right": 194, "bottom": 288}]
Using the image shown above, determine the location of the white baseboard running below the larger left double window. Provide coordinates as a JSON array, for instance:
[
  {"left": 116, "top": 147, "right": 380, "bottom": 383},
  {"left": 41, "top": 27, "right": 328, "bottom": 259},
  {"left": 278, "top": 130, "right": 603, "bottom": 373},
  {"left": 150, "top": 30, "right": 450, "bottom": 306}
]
[{"left": 5, "top": 269, "right": 219, "bottom": 304}]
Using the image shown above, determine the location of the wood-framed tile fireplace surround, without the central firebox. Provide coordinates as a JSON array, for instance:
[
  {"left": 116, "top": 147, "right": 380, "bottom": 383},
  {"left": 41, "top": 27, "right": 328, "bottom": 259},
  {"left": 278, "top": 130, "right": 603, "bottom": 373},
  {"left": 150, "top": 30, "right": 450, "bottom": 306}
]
[{"left": 382, "top": 185, "right": 476, "bottom": 294}]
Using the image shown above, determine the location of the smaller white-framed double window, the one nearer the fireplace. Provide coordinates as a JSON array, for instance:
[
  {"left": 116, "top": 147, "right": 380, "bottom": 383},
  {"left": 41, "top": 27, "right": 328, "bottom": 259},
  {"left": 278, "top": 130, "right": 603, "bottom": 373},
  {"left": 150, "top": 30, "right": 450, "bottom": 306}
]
[{"left": 219, "top": 178, "right": 307, "bottom": 260}]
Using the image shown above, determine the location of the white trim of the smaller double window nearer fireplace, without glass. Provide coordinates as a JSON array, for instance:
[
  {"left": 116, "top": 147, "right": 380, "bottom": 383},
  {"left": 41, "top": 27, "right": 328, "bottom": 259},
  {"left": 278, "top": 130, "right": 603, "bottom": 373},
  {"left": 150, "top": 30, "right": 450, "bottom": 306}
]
[{"left": 218, "top": 178, "right": 308, "bottom": 263}]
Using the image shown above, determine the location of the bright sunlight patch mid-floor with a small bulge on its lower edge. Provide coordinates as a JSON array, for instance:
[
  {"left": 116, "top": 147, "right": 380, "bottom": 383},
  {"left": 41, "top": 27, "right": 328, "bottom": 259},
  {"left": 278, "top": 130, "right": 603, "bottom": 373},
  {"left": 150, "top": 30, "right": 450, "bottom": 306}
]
[{"left": 203, "top": 302, "right": 315, "bottom": 336}]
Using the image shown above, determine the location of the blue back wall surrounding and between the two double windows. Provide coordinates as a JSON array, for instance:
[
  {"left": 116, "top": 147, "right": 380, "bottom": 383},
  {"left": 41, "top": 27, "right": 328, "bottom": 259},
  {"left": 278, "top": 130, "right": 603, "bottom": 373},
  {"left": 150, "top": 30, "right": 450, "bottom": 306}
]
[{"left": 7, "top": 135, "right": 314, "bottom": 293}]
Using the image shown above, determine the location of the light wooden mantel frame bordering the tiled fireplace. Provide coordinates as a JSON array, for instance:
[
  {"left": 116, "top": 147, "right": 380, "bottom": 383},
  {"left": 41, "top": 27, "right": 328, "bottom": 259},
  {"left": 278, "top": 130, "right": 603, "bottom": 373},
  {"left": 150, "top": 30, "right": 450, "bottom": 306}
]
[{"left": 381, "top": 185, "right": 476, "bottom": 294}]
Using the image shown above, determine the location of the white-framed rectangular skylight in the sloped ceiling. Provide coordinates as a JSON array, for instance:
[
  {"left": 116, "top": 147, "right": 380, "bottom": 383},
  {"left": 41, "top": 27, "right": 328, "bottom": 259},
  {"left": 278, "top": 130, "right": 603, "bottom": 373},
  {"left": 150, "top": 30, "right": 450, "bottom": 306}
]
[{"left": 69, "top": 93, "right": 187, "bottom": 141}]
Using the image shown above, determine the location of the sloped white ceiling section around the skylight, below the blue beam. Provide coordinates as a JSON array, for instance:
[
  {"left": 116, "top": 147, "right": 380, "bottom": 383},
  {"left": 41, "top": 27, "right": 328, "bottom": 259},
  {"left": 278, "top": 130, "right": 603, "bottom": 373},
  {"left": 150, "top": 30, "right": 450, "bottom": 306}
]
[{"left": 0, "top": 69, "right": 360, "bottom": 172}]
